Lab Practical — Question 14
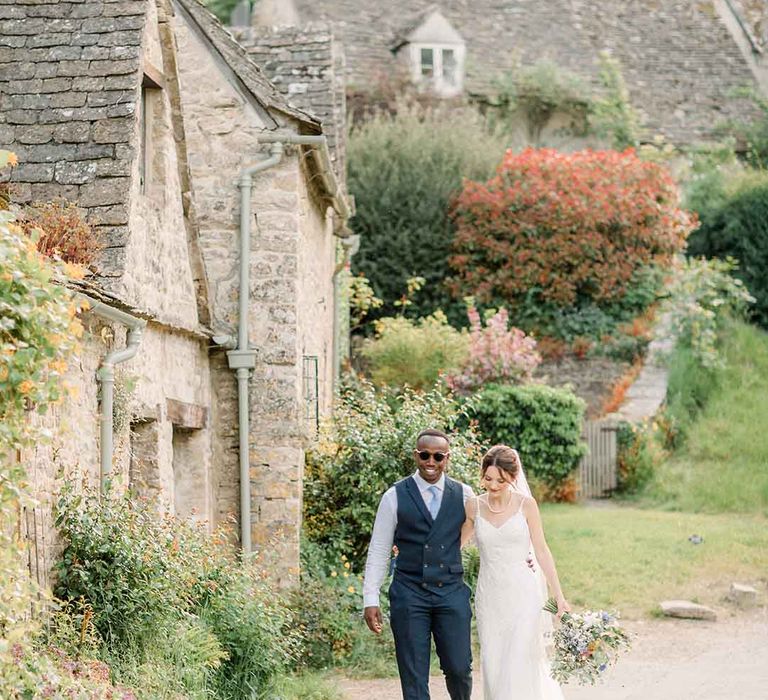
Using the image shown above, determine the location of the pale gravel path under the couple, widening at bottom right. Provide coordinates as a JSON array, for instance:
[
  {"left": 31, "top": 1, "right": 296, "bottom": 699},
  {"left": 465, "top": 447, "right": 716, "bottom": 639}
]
[{"left": 340, "top": 609, "right": 768, "bottom": 700}]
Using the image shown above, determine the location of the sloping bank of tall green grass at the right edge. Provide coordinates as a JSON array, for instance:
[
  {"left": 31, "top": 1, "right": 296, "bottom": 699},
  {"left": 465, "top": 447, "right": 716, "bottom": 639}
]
[{"left": 643, "top": 323, "right": 768, "bottom": 516}]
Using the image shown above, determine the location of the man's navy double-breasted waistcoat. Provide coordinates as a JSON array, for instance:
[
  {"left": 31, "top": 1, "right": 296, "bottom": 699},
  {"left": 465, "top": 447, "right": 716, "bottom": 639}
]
[{"left": 394, "top": 477, "right": 464, "bottom": 589}]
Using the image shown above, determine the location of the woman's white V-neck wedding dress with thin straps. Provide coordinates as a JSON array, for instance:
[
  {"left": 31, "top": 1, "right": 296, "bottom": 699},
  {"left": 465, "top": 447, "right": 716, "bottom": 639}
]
[{"left": 475, "top": 498, "right": 563, "bottom": 700}]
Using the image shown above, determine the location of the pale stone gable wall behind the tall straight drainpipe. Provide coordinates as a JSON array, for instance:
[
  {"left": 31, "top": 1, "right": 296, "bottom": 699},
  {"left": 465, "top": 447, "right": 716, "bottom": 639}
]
[{"left": 174, "top": 8, "right": 334, "bottom": 579}]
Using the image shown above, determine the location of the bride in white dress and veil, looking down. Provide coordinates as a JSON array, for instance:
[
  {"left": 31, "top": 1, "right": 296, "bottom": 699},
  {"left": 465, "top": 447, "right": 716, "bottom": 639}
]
[{"left": 461, "top": 445, "right": 571, "bottom": 700}]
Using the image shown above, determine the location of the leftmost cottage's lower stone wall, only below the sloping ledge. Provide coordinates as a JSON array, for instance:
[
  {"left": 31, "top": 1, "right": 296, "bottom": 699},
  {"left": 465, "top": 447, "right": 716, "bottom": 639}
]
[{"left": 24, "top": 312, "right": 211, "bottom": 584}]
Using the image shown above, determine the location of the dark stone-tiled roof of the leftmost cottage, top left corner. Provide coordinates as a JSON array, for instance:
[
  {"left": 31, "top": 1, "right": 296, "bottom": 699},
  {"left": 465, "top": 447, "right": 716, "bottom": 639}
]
[{"left": 0, "top": 0, "right": 145, "bottom": 260}]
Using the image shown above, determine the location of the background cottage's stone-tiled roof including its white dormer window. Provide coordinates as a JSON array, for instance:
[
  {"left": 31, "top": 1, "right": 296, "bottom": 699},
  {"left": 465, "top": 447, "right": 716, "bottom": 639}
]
[{"left": 238, "top": 0, "right": 768, "bottom": 144}]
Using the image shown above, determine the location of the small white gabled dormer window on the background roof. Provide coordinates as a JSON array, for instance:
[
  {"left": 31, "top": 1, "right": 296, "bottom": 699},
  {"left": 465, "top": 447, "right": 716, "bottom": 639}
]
[{"left": 394, "top": 8, "right": 465, "bottom": 97}]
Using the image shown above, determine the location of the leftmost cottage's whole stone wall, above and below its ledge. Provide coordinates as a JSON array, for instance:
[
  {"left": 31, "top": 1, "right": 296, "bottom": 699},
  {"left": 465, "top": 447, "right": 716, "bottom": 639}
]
[{"left": 20, "top": 0, "right": 212, "bottom": 571}]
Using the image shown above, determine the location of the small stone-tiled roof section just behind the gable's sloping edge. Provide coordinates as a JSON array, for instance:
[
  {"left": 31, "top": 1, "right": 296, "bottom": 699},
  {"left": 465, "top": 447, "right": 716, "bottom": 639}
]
[{"left": 240, "top": 24, "right": 347, "bottom": 181}]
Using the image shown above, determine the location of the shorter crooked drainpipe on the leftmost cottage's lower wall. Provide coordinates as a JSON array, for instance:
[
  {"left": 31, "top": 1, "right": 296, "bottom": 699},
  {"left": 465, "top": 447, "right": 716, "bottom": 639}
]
[{"left": 78, "top": 294, "right": 147, "bottom": 494}]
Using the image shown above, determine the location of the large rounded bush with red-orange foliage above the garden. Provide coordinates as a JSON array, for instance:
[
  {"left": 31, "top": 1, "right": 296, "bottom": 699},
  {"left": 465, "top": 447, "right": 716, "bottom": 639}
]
[{"left": 449, "top": 148, "right": 695, "bottom": 317}]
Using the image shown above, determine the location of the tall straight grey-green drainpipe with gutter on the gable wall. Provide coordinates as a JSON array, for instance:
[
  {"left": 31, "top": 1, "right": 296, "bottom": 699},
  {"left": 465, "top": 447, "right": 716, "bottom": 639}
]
[{"left": 222, "top": 133, "right": 351, "bottom": 556}]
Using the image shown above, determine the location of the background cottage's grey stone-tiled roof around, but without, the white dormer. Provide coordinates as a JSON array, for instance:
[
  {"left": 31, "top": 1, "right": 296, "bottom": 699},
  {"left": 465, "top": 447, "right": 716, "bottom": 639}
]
[{"left": 295, "top": 0, "right": 768, "bottom": 143}]
